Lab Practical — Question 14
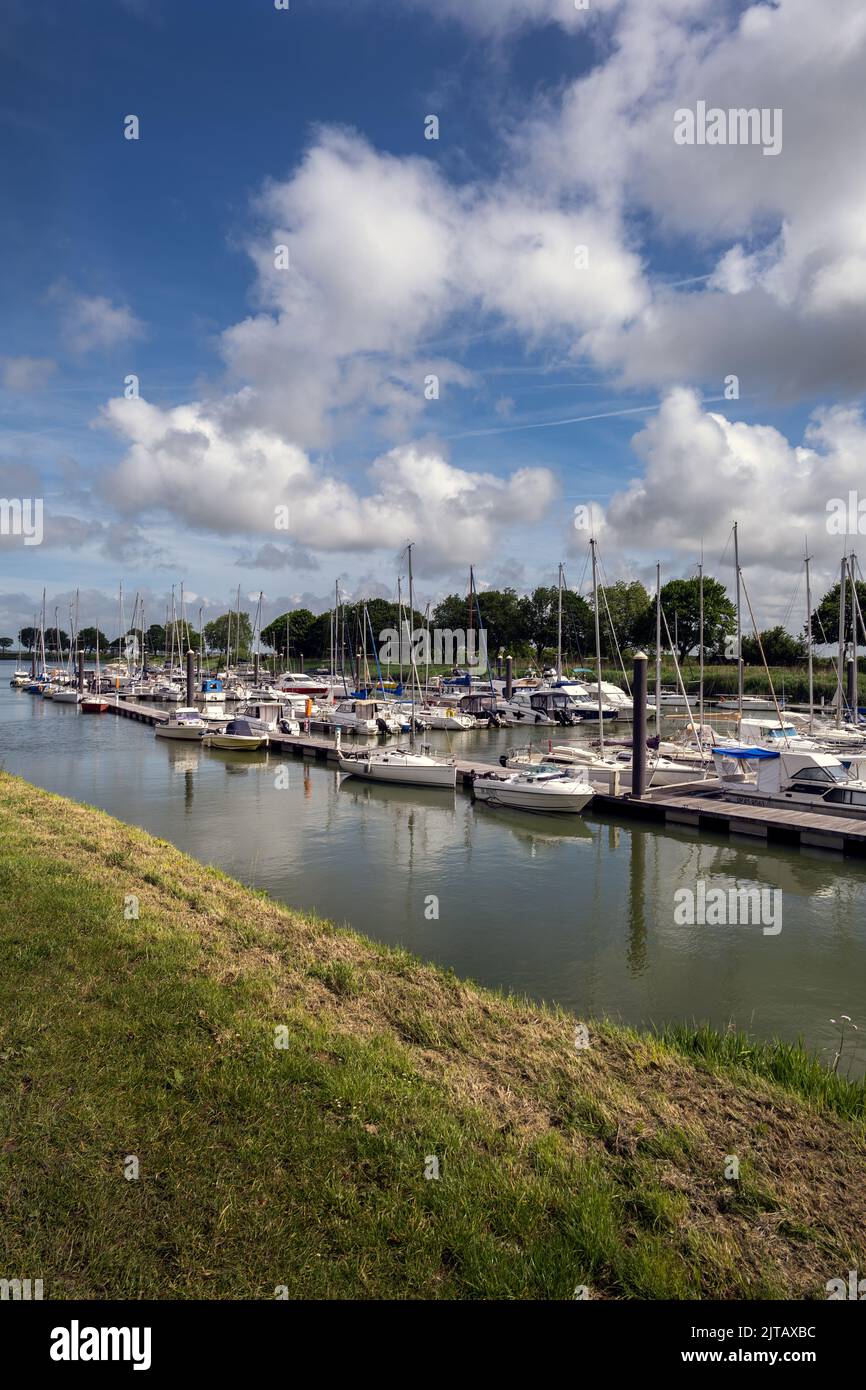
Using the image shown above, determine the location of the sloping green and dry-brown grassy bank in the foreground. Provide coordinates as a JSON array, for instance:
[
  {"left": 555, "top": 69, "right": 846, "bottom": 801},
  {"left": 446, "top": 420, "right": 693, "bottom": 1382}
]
[{"left": 0, "top": 774, "right": 866, "bottom": 1298}]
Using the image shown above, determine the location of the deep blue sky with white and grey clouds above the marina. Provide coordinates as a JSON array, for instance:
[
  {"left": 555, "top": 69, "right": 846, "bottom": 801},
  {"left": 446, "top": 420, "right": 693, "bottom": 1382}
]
[{"left": 0, "top": 0, "right": 866, "bottom": 635}]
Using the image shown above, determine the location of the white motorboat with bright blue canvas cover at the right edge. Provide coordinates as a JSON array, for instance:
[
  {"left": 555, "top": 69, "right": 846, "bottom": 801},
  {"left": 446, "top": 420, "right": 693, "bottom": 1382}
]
[{"left": 713, "top": 744, "right": 866, "bottom": 820}]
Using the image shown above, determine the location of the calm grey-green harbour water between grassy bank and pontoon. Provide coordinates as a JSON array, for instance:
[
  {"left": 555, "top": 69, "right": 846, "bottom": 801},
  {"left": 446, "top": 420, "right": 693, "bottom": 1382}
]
[{"left": 0, "top": 663, "right": 866, "bottom": 1074}]
